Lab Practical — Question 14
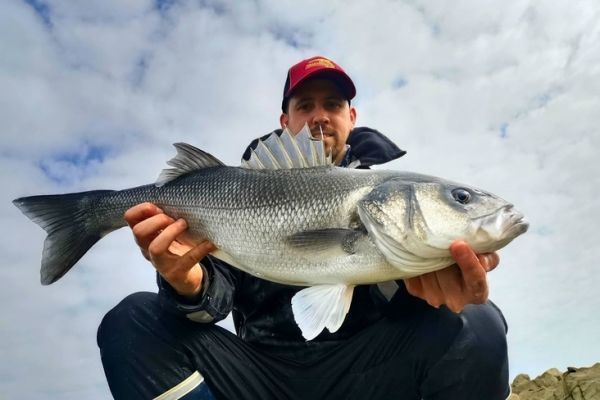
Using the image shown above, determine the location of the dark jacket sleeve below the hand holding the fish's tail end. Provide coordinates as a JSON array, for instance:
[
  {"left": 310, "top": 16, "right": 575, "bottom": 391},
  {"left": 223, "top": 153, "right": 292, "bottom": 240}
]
[{"left": 157, "top": 256, "right": 239, "bottom": 323}]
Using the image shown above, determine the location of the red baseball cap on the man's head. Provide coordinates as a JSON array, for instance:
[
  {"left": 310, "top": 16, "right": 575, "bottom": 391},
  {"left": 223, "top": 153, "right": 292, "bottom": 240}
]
[{"left": 281, "top": 56, "right": 356, "bottom": 112}]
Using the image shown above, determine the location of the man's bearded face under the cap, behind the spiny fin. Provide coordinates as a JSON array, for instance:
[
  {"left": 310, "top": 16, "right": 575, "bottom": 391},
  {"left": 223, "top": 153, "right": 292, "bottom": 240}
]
[{"left": 279, "top": 79, "right": 356, "bottom": 164}]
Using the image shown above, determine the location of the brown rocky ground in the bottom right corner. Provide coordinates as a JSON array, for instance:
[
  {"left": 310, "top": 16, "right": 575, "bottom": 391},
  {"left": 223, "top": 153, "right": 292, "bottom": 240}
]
[{"left": 508, "top": 363, "right": 600, "bottom": 400}]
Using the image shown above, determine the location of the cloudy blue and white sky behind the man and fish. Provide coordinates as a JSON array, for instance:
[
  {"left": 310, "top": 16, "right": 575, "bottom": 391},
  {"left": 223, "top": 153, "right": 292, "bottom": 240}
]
[{"left": 0, "top": 0, "right": 600, "bottom": 399}]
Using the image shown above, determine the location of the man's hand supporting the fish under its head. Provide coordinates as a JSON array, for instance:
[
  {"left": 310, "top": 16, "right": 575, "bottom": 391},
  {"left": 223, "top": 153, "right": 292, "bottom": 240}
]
[{"left": 404, "top": 241, "right": 500, "bottom": 312}]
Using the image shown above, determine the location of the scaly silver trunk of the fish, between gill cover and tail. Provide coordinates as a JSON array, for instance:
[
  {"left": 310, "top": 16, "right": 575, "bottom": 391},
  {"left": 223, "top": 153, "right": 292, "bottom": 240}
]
[{"left": 115, "top": 167, "right": 403, "bottom": 286}]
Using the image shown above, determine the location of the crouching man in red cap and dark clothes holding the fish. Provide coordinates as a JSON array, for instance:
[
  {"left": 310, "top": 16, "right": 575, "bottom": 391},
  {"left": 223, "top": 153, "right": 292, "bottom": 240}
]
[{"left": 98, "top": 57, "right": 509, "bottom": 400}]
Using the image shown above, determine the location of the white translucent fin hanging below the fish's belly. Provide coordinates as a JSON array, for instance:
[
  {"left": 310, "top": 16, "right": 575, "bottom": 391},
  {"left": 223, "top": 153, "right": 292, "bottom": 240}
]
[{"left": 292, "top": 284, "right": 354, "bottom": 340}]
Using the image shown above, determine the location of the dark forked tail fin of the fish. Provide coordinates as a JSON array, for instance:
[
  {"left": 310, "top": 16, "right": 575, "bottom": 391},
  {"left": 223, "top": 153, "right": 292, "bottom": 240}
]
[{"left": 13, "top": 190, "right": 120, "bottom": 285}]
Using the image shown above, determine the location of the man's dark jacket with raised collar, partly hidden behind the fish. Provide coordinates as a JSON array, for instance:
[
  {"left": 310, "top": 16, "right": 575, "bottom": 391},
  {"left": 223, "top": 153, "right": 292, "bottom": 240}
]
[{"left": 158, "top": 128, "right": 405, "bottom": 344}]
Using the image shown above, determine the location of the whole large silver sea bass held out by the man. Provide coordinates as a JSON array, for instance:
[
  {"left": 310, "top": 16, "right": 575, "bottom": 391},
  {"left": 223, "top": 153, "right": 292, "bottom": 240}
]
[{"left": 14, "top": 127, "right": 528, "bottom": 339}]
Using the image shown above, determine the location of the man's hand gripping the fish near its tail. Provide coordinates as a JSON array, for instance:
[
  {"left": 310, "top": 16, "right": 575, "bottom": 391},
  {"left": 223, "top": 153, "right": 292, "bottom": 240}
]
[{"left": 124, "top": 203, "right": 216, "bottom": 298}]
